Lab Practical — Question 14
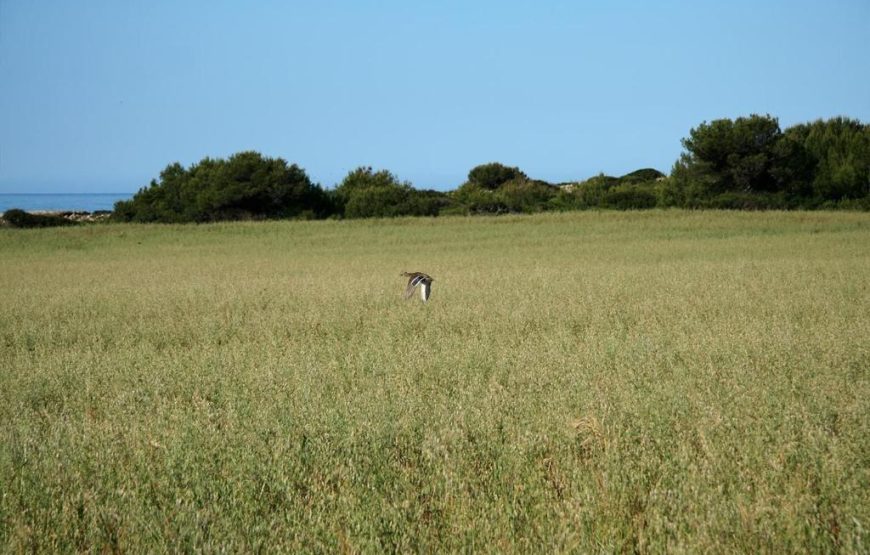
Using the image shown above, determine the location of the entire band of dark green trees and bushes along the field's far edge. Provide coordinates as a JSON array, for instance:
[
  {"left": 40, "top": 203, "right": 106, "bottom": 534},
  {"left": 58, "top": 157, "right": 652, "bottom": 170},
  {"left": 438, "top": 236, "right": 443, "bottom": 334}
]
[{"left": 114, "top": 115, "right": 870, "bottom": 222}]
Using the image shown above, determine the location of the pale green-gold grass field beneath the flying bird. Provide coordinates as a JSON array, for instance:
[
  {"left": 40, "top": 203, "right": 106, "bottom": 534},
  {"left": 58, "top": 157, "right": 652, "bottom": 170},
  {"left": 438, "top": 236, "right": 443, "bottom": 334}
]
[{"left": 0, "top": 211, "right": 870, "bottom": 553}]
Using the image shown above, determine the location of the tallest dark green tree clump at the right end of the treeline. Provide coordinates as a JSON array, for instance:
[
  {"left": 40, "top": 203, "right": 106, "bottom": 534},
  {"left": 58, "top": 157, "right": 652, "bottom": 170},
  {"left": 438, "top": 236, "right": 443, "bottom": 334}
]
[{"left": 661, "top": 115, "right": 870, "bottom": 208}]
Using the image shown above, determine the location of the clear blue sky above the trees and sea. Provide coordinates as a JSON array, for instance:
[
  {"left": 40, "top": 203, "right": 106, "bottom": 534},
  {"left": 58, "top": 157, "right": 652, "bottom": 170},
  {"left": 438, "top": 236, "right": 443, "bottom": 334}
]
[{"left": 0, "top": 0, "right": 870, "bottom": 192}]
